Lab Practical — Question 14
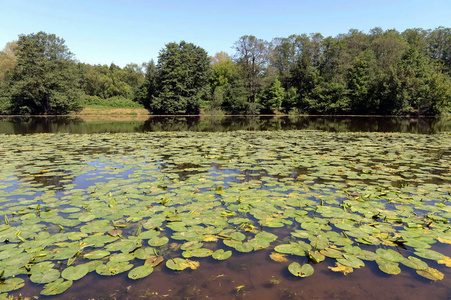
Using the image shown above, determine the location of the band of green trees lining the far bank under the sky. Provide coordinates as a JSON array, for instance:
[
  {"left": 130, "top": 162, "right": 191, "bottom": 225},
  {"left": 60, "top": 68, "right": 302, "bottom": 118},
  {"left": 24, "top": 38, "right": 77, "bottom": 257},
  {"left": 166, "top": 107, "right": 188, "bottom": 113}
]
[{"left": 0, "top": 27, "right": 451, "bottom": 116}]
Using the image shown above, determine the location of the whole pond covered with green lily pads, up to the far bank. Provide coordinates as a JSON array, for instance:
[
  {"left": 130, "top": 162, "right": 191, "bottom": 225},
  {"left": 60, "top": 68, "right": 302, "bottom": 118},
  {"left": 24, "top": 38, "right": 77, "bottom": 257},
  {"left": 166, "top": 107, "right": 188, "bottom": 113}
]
[{"left": 0, "top": 117, "right": 451, "bottom": 299}]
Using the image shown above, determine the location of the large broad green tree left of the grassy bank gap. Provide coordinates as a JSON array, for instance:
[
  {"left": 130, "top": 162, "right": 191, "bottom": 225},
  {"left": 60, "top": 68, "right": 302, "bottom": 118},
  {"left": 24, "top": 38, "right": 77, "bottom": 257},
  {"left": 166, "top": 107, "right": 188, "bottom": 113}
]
[{"left": 10, "top": 32, "right": 81, "bottom": 114}]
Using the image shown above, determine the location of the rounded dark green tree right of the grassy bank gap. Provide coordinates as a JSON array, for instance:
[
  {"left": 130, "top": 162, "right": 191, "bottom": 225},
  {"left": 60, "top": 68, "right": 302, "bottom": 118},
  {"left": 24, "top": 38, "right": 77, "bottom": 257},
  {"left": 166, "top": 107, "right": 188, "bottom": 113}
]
[{"left": 148, "top": 41, "right": 211, "bottom": 114}]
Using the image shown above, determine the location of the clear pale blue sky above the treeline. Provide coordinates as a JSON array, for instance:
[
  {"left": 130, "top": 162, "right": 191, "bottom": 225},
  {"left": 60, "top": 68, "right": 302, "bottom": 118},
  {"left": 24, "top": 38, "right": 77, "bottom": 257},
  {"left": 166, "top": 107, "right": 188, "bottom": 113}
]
[{"left": 0, "top": 0, "right": 451, "bottom": 67}]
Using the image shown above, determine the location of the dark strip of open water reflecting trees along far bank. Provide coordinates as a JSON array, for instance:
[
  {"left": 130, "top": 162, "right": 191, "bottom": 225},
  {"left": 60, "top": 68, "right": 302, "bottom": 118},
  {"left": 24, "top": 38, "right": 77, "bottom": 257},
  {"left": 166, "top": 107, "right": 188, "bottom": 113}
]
[{"left": 0, "top": 116, "right": 451, "bottom": 134}]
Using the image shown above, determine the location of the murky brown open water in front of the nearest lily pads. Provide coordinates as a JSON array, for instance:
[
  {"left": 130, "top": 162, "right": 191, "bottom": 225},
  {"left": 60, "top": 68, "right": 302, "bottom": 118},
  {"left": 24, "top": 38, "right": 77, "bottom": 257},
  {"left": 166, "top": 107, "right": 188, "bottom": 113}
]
[{"left": 15, "top": 247, "right": 451, "bottom": 300}]
